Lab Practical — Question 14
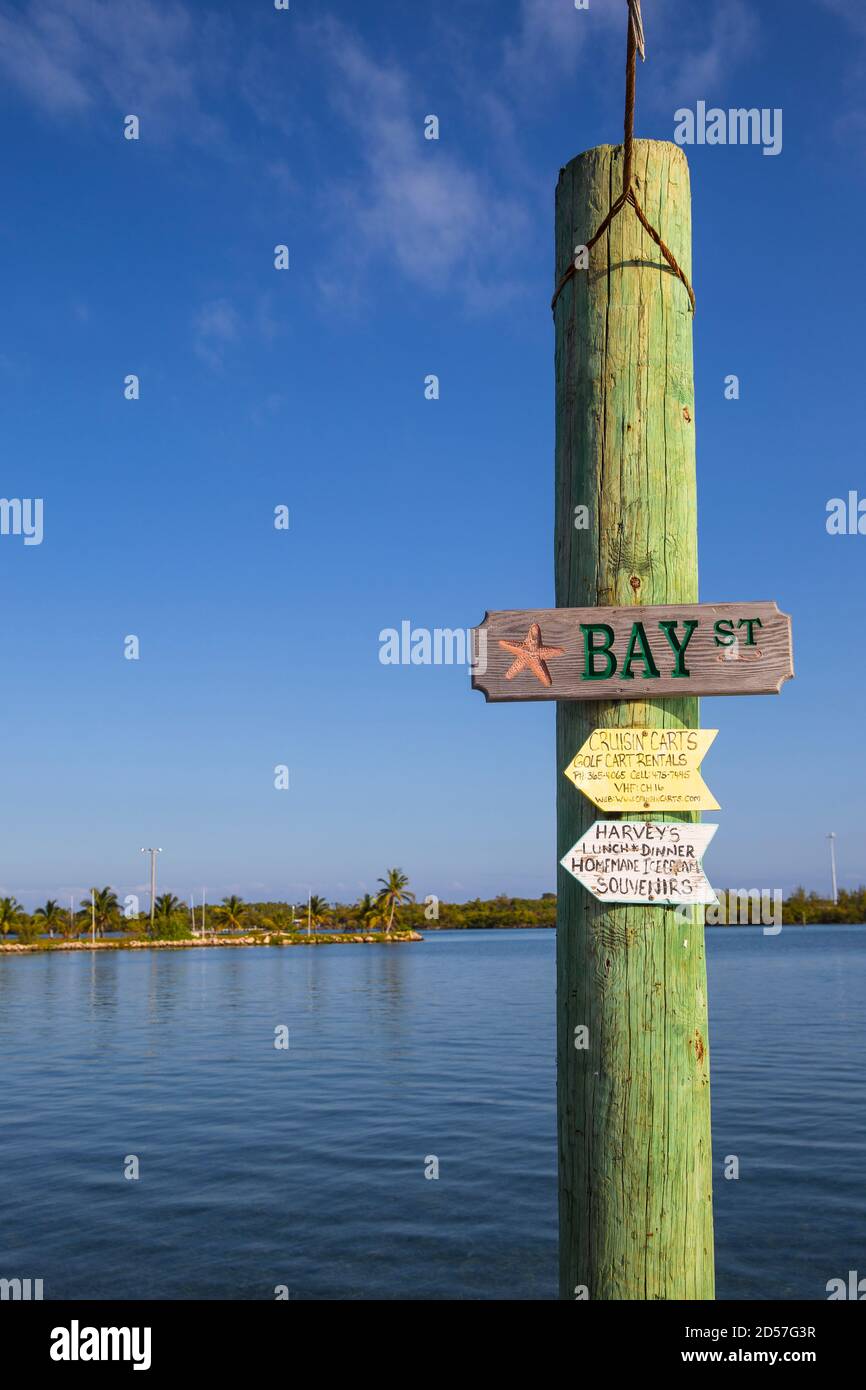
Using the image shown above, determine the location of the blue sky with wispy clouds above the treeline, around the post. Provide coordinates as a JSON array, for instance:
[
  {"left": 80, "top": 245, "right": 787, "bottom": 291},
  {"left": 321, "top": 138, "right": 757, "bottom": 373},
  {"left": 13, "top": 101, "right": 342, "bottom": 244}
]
[{"left": 0, "top": 0, "right": 866, "bottom": 906}]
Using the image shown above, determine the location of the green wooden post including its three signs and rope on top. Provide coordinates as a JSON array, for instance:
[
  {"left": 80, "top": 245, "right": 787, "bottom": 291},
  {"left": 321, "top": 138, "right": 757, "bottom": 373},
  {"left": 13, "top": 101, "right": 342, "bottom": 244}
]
[{"left": 471, "top": 0, "right": 794, "bottom": 1301}]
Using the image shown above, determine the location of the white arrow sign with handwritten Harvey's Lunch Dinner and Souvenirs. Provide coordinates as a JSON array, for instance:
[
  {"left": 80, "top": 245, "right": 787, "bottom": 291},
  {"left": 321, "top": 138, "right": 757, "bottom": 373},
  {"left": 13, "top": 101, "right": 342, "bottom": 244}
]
[{"left": 560, "top": 820, "right": 719, "bottom": 906}]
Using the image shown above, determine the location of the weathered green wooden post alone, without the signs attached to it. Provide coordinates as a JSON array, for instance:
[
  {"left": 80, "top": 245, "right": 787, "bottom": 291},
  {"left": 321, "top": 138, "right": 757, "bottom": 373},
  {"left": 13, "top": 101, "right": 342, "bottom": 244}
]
[{"left": 555, "top": 140, "right": 713, "bottom": 1300}]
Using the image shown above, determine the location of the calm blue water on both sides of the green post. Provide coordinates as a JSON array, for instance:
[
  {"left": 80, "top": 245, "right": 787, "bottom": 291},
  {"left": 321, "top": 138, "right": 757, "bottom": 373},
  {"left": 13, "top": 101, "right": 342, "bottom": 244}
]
[{"left": 0, "top": 927, "right": 866, "bottom": 1298}]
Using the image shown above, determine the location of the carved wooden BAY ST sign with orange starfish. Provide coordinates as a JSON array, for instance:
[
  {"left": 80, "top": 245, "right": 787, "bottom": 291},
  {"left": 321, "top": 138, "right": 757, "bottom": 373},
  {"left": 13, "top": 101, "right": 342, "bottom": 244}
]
[{"left": 473, "top": 602, "right": 794, "bottom": 701}]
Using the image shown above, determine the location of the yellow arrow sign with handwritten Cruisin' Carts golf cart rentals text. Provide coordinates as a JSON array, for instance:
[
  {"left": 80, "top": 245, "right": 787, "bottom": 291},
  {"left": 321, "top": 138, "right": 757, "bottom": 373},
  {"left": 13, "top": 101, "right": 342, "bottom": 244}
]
[{"left": 566, "top": 728, "right": 719, "bottom": 810}]
